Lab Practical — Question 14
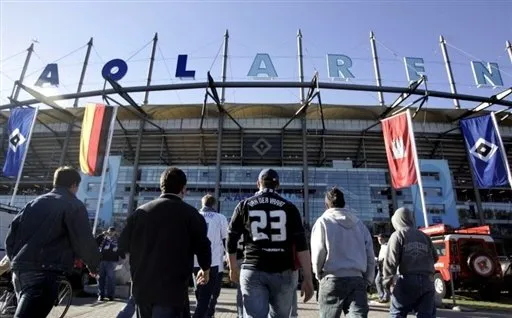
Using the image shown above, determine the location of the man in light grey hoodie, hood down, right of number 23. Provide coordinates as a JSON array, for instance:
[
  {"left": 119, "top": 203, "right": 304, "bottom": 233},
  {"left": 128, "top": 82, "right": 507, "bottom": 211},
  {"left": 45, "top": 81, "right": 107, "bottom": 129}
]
[{"left": 311, "top": 188, "right": 375, "bottom": 318}]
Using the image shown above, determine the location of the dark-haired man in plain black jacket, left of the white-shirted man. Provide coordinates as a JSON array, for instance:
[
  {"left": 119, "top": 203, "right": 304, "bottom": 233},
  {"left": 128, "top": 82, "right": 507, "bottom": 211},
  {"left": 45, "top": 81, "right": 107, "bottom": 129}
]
[{"left": 119, "top": 168, "right": 212, "bottom": 318}]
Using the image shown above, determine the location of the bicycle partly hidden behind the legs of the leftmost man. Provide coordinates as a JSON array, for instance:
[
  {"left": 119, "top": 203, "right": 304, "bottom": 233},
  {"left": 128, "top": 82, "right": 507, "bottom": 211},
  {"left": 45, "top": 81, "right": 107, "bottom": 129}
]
[{"left": 0, "top": 278, "right": 73, "bottom": 318}]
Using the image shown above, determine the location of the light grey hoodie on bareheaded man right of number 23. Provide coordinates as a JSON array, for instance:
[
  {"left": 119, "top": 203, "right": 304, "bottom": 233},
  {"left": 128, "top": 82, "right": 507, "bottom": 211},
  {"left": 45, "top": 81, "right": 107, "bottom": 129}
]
[{"left": 311, "top": 208, "right": 375, "bottom": 282}]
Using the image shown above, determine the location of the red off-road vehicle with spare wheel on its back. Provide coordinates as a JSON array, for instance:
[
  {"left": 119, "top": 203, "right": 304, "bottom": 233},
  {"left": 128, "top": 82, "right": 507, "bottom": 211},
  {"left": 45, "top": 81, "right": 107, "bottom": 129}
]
[{"left": 421, "top": 224, "right": 503, "bottom": 300}]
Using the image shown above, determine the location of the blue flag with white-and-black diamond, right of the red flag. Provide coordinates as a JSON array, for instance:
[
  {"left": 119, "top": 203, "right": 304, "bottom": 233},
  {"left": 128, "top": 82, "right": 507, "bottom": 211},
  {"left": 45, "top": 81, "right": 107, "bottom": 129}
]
[{"left": 460, "top": 113, "right": 512, "bottom": 189}]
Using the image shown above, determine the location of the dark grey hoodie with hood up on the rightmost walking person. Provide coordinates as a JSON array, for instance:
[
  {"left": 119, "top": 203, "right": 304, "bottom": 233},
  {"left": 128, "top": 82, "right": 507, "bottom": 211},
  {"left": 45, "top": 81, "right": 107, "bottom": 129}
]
[{"left": 383, "top": 208, "right": 437, "bottom": 283}]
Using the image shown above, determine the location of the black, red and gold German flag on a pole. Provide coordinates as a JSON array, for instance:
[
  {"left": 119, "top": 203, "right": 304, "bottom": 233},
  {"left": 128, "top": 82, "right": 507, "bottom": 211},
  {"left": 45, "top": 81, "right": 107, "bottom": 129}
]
[{"left": 80, "top": 104, "right": 114, "bottom": 176}]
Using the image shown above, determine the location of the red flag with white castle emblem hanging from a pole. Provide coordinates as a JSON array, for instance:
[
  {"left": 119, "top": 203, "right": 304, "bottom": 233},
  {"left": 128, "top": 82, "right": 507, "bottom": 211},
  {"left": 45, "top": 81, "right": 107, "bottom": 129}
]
[{"left": 381, "top": 110, "right": 419, "bottom": 189}]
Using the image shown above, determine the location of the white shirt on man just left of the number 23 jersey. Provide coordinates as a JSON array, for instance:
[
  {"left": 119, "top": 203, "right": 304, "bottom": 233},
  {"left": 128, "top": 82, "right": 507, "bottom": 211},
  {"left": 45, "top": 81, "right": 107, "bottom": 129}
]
[{"left": 194, "top": 211, "right": 228, "bottom": 271}]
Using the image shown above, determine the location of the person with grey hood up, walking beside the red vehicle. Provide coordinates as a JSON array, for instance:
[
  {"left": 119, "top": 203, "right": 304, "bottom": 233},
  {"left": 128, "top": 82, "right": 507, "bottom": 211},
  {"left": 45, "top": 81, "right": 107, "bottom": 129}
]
[{"left": 383, "top": 208, "right": 438, "bottom": 318}]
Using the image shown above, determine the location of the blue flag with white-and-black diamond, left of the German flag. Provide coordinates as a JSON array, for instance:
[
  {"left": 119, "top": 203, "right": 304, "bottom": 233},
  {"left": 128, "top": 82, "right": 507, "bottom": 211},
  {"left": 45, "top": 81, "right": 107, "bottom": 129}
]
[{"left": 3, "top": 108, "right": 37, "bottom": 177}]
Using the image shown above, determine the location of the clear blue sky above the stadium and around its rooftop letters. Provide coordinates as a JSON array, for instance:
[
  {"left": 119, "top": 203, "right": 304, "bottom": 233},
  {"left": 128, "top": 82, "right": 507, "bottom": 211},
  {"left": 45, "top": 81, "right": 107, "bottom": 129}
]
[{"left": 0, "top": 0, "right": 512, "bottom": 107}]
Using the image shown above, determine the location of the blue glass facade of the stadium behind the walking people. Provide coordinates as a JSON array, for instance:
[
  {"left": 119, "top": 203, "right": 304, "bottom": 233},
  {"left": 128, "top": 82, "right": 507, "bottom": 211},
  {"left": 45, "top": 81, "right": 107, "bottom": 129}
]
[{"left": 0, "top": 160, "right": 512, "bottom": 234}]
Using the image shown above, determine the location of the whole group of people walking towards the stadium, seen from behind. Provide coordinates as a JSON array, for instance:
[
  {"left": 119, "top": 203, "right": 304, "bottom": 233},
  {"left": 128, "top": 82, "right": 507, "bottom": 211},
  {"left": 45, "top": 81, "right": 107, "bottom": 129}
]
[{"left": 2, "top": 167, "right": 437, "bottom": 318}]
